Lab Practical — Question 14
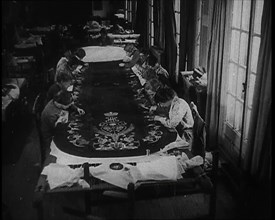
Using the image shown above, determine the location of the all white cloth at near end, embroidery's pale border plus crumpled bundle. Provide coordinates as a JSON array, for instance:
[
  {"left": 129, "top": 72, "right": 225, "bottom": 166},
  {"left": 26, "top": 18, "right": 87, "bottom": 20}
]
[{"left": 41, "top": 136, "right": 203, "bottom": 189}]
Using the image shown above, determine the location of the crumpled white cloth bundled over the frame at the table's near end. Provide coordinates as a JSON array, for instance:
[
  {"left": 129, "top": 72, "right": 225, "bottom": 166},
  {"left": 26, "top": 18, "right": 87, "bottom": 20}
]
[{"left": 42, "top": 153, "right": 203, "bottom": 189}]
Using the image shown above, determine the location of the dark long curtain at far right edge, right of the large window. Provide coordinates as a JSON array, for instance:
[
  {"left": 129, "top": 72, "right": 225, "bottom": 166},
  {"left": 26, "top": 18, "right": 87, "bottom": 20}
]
[{"left": 244, "top": 0, "right": 272, "bottom": 182}]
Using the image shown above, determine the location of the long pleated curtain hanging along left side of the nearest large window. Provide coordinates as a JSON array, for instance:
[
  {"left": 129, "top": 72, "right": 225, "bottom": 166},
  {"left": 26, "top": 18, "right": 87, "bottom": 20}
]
[{"left": 205, "top": 0, "right": 227, "bottom": 150}]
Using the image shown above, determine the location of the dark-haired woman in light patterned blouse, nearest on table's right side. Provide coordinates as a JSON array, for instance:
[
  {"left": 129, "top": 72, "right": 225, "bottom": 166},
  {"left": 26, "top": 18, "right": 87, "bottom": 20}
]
[{"left": 150, "top": 87, "right": 194, "bottom": 149}]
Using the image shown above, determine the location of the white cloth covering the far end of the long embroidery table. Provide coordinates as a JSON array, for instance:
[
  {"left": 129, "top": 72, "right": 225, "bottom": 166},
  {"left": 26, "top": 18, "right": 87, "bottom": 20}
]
[{"left": 82, "top": 46, "right": 126, "bottom": 62}]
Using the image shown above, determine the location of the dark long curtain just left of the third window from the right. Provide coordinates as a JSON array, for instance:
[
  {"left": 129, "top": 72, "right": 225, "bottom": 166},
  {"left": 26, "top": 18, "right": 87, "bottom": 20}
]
[{"left": 163, "top": 0, "right": 177, "bottom": 84}]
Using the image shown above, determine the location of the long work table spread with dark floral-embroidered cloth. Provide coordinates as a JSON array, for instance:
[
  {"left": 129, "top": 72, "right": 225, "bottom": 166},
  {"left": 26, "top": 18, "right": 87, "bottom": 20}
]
[{"left": 35, "top": 47, "right": 218, "bottom": 218}]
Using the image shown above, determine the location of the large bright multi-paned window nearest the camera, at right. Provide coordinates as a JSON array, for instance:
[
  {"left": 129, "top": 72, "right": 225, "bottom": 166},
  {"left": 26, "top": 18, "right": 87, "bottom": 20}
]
[{"left": 224, "top": 0, "right": 264, "bottom": 163}]
